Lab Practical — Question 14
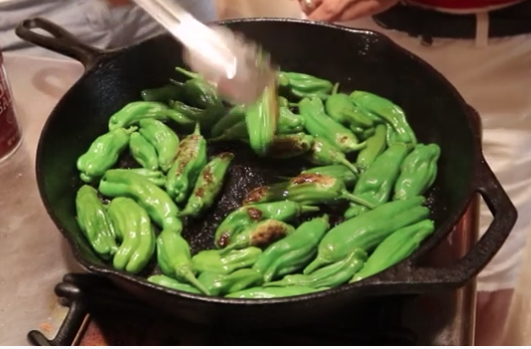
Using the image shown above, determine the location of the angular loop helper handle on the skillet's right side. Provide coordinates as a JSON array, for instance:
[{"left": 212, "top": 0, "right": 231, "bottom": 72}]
[{"left": 402, "top": 157, "right": 518, "bottom": 291}]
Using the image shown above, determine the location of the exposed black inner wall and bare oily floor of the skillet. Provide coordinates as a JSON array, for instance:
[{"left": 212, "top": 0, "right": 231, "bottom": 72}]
[{"left": 37, "top": 20, "right": 480, "bottom": 282}]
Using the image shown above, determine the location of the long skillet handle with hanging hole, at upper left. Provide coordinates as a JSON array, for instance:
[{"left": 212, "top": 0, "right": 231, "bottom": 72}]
[{"left": 15, "top": 17, "right": 105, "bottom": 70}]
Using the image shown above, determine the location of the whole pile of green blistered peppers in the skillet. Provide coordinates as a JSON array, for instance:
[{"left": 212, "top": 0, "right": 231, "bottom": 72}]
[{"left": 75, "top": 67, "right": 440, "bottom": 298}]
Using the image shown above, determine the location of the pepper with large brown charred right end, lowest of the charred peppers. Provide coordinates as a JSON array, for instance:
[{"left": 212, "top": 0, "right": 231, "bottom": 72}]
[{"left": 220, "top": 219, "right": 294, "bottom": 256}]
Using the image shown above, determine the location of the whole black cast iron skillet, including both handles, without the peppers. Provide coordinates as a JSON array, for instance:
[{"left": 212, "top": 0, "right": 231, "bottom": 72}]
[{"left": 16, "top": 18, "right": 517, "bottom": 326}]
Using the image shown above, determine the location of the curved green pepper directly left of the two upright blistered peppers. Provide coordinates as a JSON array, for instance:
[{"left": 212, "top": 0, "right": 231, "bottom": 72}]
[{"left": 139, "top": 119, "right": 179, "bottom": 172}]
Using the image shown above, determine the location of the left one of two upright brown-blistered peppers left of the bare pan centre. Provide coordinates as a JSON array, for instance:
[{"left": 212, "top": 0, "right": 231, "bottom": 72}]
[{"left": 166, "top": 124, "right": 207, "bottom": 203}]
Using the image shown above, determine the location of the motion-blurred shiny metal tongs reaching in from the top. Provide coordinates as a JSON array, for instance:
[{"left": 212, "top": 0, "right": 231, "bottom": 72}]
[{"left": 134, "top": 0, "right": 276, "bottom": 104}]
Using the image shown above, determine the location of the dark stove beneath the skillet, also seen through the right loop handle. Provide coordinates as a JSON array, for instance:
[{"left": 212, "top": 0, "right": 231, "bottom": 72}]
[{"left": 28, "top": 196, "right": 477, "bottom": 346}]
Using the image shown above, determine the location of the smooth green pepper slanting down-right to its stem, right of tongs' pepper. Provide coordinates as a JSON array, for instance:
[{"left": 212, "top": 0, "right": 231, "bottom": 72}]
[{"left": 299, "top": 98, "right": 365, "bottom": 153}]
